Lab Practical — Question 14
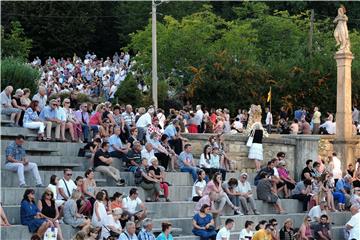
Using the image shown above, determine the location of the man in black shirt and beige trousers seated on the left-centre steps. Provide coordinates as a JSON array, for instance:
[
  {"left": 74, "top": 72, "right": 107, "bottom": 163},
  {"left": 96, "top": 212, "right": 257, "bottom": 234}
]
[{"left": 94, "top": 142, "right": 125, "bottom": 186}]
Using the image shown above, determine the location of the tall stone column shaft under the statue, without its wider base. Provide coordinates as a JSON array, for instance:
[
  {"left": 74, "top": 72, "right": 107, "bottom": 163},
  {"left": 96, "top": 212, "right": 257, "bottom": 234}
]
[{"left": 335, "top": 51, "right": 354, "bottom": 139}]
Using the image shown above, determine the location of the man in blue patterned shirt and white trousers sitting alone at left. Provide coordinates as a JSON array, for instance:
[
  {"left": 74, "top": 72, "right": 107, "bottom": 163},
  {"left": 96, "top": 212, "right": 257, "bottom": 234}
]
[{"left": 5, "top": 135, "right": 43, "bottom": 188}]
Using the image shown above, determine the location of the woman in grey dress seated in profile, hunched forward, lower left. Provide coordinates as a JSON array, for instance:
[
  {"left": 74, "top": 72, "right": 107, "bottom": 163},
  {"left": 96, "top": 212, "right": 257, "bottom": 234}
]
[{"left": 63, "top": 190, "right": 91, "bottom": 231}]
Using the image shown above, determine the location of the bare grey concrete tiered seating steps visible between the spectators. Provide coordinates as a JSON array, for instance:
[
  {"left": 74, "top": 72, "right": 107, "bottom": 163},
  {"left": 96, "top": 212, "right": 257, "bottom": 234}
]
[{"left": 1, "top": 115, "right": 350, "bottom": 240}]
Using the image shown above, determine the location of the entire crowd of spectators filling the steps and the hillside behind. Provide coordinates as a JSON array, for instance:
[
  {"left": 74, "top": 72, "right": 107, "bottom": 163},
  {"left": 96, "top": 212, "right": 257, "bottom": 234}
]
[{"left": 0, "top": 57, "right": 360, "bottom": 240}]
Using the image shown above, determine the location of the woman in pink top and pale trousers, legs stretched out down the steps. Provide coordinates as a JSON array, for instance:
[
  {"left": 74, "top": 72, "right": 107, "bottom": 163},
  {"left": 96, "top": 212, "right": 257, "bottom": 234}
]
[{"left": 203, "top": 172, "right": 243, "bottom": 215}]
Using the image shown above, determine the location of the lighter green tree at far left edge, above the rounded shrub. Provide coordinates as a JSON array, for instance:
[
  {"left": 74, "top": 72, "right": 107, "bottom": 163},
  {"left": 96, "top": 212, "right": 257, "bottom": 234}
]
[{"left": 1, "top": 21, "right": 32, "bottom": 60}]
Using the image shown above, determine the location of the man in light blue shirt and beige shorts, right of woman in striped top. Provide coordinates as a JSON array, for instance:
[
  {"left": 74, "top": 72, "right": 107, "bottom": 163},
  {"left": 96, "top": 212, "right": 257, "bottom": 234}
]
[{"left": 39, "top": 99, "right": 65, "bottom": 141}]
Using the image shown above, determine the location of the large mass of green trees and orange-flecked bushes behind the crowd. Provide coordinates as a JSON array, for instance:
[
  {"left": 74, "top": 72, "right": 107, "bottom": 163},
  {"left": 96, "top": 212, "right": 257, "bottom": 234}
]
[{"left": 127, "top": 2, "right": 360, "bottom": 112}]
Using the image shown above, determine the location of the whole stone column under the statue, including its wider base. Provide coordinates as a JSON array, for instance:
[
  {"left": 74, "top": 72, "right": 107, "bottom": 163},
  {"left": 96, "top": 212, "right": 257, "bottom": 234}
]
[{"left": 333, "top": 51, "right": 355, "bottom": 170}]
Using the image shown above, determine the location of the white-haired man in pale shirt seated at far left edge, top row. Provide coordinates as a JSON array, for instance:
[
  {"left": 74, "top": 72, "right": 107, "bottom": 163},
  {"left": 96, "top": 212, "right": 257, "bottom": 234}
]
[{"left": 0, "top": 86, "right": 21, "bottom": 126}]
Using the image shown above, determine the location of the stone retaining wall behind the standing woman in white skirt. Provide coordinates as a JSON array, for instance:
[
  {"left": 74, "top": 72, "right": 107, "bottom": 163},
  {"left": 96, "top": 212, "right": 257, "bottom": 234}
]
[{"left": 184, "top": 134, "right": 297, "bottom": 177}]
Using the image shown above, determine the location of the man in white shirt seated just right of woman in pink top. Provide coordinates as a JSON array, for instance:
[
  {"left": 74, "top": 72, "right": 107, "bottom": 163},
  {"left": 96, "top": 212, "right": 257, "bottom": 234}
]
[{"left": 236, "top": 172, "right": 260, "bottom": 215}]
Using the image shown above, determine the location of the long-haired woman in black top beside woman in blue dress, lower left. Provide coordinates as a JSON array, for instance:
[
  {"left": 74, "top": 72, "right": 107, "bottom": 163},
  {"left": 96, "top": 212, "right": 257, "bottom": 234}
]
[{"left": 37, "top": 188, "right": 64, "bottom": 240}]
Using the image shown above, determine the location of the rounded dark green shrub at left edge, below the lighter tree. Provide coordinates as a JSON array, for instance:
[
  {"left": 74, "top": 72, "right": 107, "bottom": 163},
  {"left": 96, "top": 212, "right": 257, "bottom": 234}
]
[{"left": 1, "top": 58, "right": 40, "bottom": 94}]
